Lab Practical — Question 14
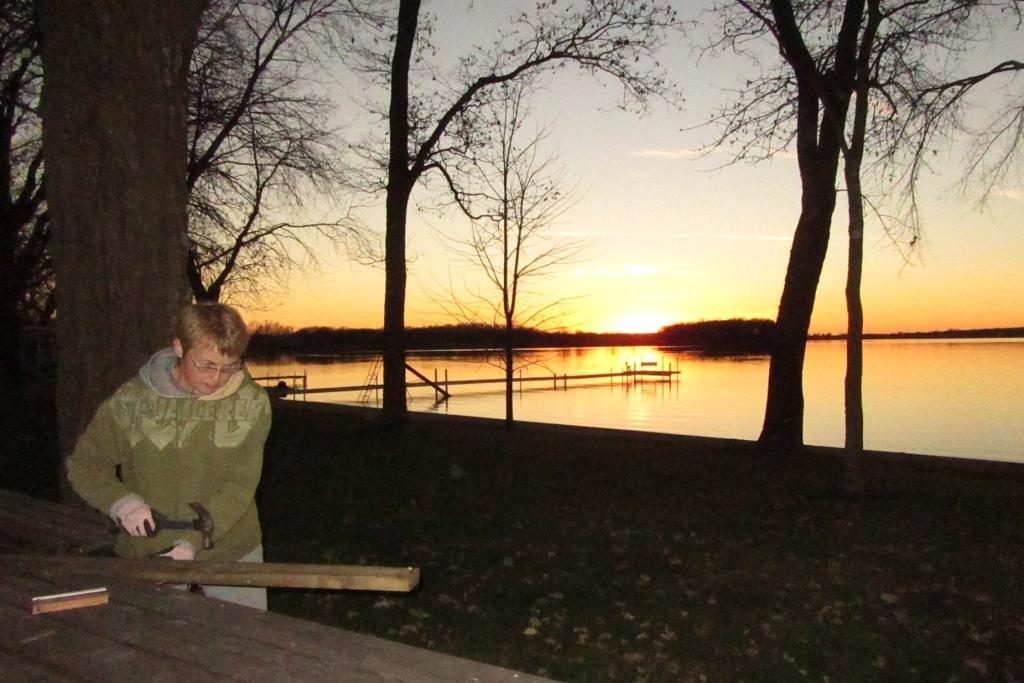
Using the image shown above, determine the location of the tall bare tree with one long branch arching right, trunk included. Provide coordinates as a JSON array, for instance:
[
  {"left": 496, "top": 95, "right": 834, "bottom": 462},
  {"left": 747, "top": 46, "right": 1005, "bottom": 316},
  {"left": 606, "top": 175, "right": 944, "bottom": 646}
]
[{"left": 352, "top": 0, "right": 676, "bottom": 424}]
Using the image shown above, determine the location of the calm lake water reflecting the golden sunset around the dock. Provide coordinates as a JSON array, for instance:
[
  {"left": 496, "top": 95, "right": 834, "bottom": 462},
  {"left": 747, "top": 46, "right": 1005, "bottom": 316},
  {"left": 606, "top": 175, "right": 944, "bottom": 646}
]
[{"left": 249, "top": 339, "right": 1024, "bottom": 462}]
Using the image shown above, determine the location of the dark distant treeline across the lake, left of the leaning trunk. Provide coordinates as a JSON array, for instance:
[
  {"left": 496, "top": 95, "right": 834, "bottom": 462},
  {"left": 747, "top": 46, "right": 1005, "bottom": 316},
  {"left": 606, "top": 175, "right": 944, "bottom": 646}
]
[{"left": 249, "top": 319, "right": 775, "bottom": 356}]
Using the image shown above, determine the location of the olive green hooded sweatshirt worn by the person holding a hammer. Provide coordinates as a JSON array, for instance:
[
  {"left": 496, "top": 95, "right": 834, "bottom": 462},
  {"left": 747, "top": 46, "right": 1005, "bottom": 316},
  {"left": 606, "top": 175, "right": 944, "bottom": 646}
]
[{"left": 68, "top": 348, "right": 270, "bottom": 561}]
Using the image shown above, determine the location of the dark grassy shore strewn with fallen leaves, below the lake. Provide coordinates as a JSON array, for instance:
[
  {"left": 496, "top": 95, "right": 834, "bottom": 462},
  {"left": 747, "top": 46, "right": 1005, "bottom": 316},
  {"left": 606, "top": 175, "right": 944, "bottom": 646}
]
[{"left": 260, "top": 404, "right": 1024, "bottom": 681}]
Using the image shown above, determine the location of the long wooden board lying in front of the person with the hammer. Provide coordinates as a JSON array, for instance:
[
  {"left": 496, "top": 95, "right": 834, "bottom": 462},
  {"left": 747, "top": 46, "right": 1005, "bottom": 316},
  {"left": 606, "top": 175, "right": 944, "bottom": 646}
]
[{"left": 0, "top": 555, "right": 420, "bottom": 593}]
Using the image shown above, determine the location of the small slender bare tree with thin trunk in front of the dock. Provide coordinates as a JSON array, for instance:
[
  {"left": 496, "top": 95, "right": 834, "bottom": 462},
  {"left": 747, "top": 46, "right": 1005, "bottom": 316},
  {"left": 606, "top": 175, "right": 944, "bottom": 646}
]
[{"left": 430, "top": 82, "right": 586, "bottom": 428}]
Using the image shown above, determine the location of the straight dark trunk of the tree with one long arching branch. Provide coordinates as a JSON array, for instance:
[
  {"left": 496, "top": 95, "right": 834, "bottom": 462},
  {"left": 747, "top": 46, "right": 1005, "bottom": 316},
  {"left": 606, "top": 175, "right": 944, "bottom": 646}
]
[{"left": 383, "top": 0, "right": 420, "bottom": 425}]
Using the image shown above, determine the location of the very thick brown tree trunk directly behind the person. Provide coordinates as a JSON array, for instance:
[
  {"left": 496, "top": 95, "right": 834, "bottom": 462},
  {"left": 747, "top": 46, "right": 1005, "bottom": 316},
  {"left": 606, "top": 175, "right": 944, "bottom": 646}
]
[{"left": 39, "top": 0, "right": 203, "bottom": 494}]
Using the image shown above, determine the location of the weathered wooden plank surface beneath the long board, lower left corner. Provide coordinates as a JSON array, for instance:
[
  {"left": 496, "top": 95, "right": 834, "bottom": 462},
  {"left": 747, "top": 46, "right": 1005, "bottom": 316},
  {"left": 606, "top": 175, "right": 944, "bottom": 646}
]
[{"left": 0, "top": 489, "right": 557, "bottom": 683}]
